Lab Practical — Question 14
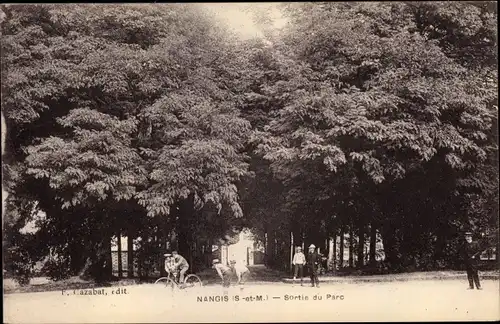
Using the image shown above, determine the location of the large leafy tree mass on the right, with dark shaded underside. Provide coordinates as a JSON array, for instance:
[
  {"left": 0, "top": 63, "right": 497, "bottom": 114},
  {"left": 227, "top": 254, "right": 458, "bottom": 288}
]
[{"left": 246, "top": 3, "right": 497, "bottom": 266}]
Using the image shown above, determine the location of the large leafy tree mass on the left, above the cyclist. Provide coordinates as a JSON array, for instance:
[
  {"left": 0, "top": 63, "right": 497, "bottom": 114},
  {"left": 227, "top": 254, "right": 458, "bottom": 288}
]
[{"left": 2, "top": 4, "right": 254, "bottom": 280}]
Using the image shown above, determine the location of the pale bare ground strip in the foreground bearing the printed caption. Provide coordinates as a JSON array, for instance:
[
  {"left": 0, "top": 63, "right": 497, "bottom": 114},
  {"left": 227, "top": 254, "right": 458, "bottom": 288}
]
[{"left": 4, "top": 280, "right": 500, "bottom": 323}]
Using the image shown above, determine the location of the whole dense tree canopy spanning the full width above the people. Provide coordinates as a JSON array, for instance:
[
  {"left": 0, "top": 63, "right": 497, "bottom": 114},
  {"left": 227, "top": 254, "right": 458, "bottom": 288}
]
[{"left": 1, "top": 2, "right": 498, "bottom": 280}]
